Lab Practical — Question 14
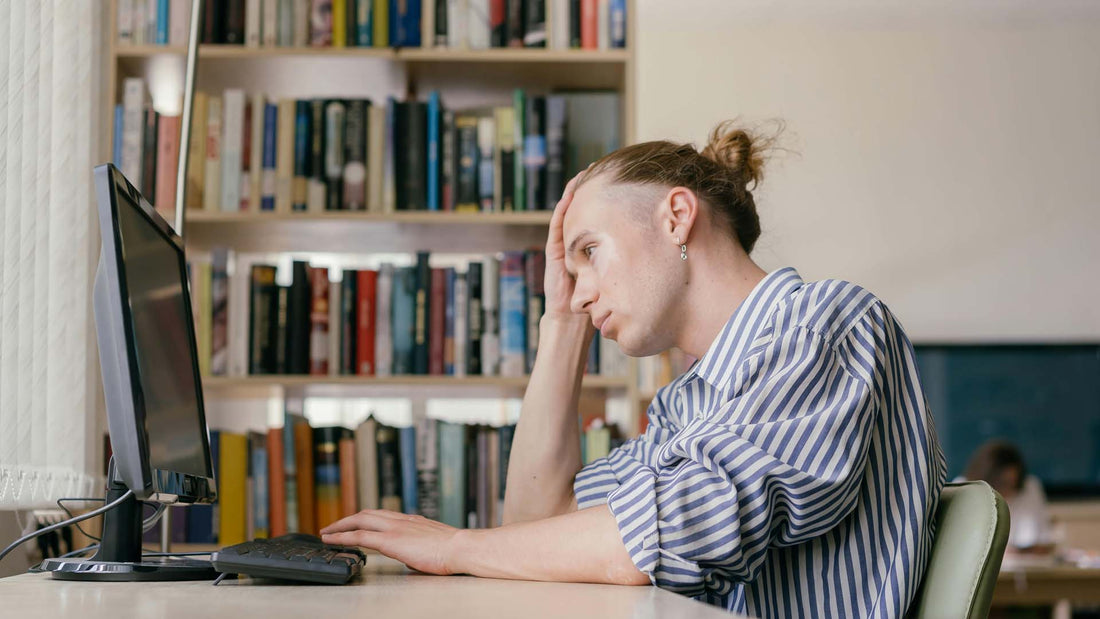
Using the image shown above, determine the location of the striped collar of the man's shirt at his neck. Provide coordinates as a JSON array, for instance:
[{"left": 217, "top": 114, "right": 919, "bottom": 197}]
[{"left": 690, "top": 267, "right": 802, "bottom": 388}]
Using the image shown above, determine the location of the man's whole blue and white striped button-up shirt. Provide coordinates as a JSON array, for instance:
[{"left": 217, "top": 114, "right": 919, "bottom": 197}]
[{"left": 573, "top": 268, "right": 946, "bottom": 617}]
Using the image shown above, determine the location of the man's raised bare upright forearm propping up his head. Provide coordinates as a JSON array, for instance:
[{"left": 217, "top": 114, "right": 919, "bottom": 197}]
[{"left": 503, "top": 316, "right": 592, "bottom": 524}]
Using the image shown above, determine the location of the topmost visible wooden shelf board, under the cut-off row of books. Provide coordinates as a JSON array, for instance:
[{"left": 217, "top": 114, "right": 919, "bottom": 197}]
[{"left": 116, "top": 45, "right": 629, "bottom": 63}]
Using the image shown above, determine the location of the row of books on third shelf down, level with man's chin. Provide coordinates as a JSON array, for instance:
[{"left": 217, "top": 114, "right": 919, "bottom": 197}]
[{"left": 189, "top": 248, "right": 628, "bottom": 377}]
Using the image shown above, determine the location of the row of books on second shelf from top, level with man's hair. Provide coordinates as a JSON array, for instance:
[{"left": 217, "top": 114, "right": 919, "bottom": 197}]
[{"left": 114, "top": 78, "right": 620, "bottom": 212}]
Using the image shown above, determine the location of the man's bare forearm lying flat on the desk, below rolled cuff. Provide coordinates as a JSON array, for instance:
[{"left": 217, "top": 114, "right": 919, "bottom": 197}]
[{"left": 448, "top": 505, "right": 650, "bottom": 585}]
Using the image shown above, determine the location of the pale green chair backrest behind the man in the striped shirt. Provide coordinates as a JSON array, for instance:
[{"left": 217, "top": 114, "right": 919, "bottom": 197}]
[{"left": 909, "top": 482, "right": 1009, "bottom": 619}]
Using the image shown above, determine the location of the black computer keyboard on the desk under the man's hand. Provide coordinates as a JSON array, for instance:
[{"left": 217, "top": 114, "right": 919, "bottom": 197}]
[{"left": 210, "top": 533, "right": 366, "bottom": 585}]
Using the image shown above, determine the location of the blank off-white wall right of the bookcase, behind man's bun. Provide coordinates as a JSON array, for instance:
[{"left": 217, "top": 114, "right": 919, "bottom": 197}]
[{"left": 637, "top": 0, "right": 1100, "bottom": 341}]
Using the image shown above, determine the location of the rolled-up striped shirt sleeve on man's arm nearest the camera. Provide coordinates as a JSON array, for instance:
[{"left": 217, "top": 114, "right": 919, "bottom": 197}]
[{"left": 602, "top": 328, "right": 877, "bottom": 595}]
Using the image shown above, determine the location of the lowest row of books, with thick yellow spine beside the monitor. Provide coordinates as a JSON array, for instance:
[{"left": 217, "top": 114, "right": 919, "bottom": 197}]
[{"left": 139, "top": 400, "right": 622, "bottom": 546}]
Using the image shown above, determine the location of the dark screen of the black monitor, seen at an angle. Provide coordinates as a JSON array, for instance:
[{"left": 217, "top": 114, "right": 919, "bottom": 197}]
[{"left": 118, "top": 186, "right": 210, "bottom": 477}]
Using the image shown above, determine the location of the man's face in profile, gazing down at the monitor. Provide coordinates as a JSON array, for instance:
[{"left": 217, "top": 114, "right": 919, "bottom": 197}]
[{"left": 562, "top": 178, "right": 679, "bottom": 356}]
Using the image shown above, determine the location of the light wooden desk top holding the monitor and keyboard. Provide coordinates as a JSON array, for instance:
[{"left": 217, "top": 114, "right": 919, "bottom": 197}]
[{"left": 0, "top": 555, "right": 734, "bottom": 619}]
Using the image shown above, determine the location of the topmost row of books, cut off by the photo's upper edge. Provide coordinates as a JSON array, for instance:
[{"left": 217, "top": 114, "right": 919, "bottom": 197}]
[{"left": 118, "top": 0, "right": 627, "bottom": 49}]
